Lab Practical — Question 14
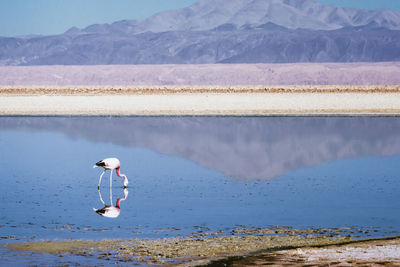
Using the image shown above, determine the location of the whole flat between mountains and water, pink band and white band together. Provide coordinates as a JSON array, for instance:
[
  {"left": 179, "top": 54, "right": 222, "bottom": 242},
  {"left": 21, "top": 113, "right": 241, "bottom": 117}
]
[{"left": 0, "top": 62, "right": 400, "bottom": 115}]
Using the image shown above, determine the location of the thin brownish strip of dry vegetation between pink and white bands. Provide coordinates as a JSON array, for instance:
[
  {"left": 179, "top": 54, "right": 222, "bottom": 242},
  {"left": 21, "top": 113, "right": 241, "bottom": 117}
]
[{"left": 0, "top": 85, "right": 400, "bottom": 95}]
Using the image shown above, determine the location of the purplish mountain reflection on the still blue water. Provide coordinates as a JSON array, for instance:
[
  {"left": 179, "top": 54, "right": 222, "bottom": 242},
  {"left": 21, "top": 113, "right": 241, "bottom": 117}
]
[{"left": 0, "top": 117, "right": 400, "bottom": 180}]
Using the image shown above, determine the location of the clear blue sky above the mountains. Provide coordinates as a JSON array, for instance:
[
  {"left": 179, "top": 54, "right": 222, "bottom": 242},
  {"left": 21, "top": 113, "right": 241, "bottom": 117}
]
[{"left": 0, "top": 0, "right": 400, "bottom": 36}]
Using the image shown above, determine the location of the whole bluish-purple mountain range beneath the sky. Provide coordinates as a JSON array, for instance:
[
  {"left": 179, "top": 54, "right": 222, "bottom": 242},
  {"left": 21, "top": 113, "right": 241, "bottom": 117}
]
[{"left": 0, "top": 0, "right": 400, "bottom": 65}]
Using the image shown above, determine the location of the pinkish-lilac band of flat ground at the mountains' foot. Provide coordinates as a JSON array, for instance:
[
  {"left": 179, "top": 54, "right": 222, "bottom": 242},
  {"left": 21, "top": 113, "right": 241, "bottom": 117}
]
[{"left": 0, "top": 62, "right": 400, "bottom": 86}]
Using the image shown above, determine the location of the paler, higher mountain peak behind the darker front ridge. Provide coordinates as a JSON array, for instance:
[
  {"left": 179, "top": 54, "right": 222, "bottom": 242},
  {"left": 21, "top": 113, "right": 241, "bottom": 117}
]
[{"left": 78, "top": 0, "right": 400, "bottom": 34}]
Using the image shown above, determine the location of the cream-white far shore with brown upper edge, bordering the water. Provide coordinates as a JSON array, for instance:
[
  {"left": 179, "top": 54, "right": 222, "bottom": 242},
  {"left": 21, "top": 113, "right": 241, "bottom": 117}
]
[{"left": 0, "top": 85, "right": 400, "bottom": 115}]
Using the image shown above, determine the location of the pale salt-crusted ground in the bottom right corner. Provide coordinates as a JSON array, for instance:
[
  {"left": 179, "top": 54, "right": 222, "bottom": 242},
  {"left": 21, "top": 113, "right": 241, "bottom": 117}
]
[{"left": 206, "top": 236, "right": 400, "bottom": 266}]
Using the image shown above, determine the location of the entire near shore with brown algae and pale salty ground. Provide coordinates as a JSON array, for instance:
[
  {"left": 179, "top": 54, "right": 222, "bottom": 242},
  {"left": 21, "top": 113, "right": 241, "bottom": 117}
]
[{"left": 6, "top": 228, "right": 400, "bottom": 266}]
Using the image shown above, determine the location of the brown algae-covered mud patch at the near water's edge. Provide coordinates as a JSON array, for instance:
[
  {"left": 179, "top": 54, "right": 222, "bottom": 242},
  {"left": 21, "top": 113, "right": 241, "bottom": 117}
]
[{"left": 6, "top": 228, "right": 354, "bottom": 264}]
